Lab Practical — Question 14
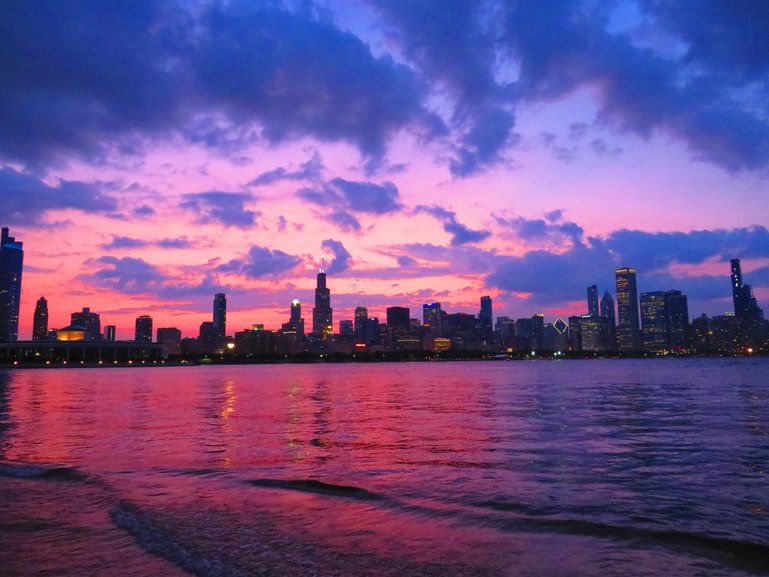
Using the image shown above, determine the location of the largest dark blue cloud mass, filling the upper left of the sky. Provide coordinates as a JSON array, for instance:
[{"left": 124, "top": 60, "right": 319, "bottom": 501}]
[{"left": 0, "top": 0, "right": 438, "bottom": 166}]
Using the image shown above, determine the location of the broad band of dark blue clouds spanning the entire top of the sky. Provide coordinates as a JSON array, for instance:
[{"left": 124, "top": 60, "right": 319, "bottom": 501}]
[{"left": 0, "top": 0, "right": 769, "bottom": 176}]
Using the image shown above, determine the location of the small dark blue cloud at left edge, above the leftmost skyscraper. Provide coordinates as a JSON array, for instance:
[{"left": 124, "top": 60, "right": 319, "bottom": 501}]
[{"left": 0, "top": 165, "right": 118, "bottom": 225}]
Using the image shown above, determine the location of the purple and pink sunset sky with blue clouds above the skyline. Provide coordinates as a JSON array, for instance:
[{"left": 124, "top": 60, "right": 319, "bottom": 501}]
[{"left": 0, "top": 0, "right": 769, "bottom": 339}]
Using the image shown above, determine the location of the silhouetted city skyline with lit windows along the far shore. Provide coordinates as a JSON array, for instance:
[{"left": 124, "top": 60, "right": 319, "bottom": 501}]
[{"left": 0, "top": 227, "right": 769, "bottom": 357}]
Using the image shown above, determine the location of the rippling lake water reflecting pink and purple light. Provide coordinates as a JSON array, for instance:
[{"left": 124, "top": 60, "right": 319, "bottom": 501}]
[{"left": 0, "top": 359, "right": 769, "bottom": 577}]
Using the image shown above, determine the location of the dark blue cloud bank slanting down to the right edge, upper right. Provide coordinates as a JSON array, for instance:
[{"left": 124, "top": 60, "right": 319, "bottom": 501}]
[{"left": 504, "top": 1, "right": 769, "bottom": 170}]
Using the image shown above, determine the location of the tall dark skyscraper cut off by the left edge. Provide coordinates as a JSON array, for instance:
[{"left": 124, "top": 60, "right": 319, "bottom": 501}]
[{"left": 0, "top": 227, "right": 24, "bottom": 342}]
